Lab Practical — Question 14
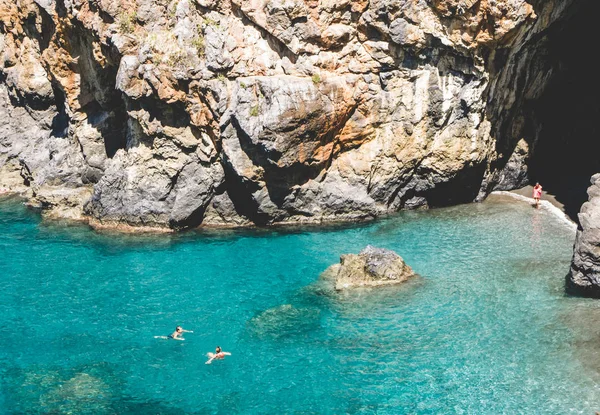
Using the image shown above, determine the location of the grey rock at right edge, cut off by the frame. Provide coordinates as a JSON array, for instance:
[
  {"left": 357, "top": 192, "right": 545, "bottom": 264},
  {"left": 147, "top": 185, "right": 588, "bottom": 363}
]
[{"left": 567, "top": 173, "right": 600, "bottom": 298}]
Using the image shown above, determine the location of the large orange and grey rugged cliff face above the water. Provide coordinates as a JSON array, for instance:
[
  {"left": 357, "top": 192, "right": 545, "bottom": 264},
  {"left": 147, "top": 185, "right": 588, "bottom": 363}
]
[{"left": 0, "top": 0, "right": 576, "bottom": 229}]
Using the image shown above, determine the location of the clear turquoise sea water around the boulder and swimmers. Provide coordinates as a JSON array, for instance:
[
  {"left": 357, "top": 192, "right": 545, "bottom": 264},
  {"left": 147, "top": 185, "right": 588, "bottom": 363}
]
[{"left": 0, "top": 199, "right": 600, "bottom": 414}]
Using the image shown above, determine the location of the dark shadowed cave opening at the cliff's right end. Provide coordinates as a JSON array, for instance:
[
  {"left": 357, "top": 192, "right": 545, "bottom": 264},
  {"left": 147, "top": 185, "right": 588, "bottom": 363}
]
[{"left": 529, "top": 0, "right": 600, "bottom": 220}]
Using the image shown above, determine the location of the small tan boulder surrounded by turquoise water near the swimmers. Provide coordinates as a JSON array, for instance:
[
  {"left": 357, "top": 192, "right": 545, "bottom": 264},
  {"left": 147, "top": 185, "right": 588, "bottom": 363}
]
[{"left": 322, "top": 245, "right": 416, "bottom": 290}]
